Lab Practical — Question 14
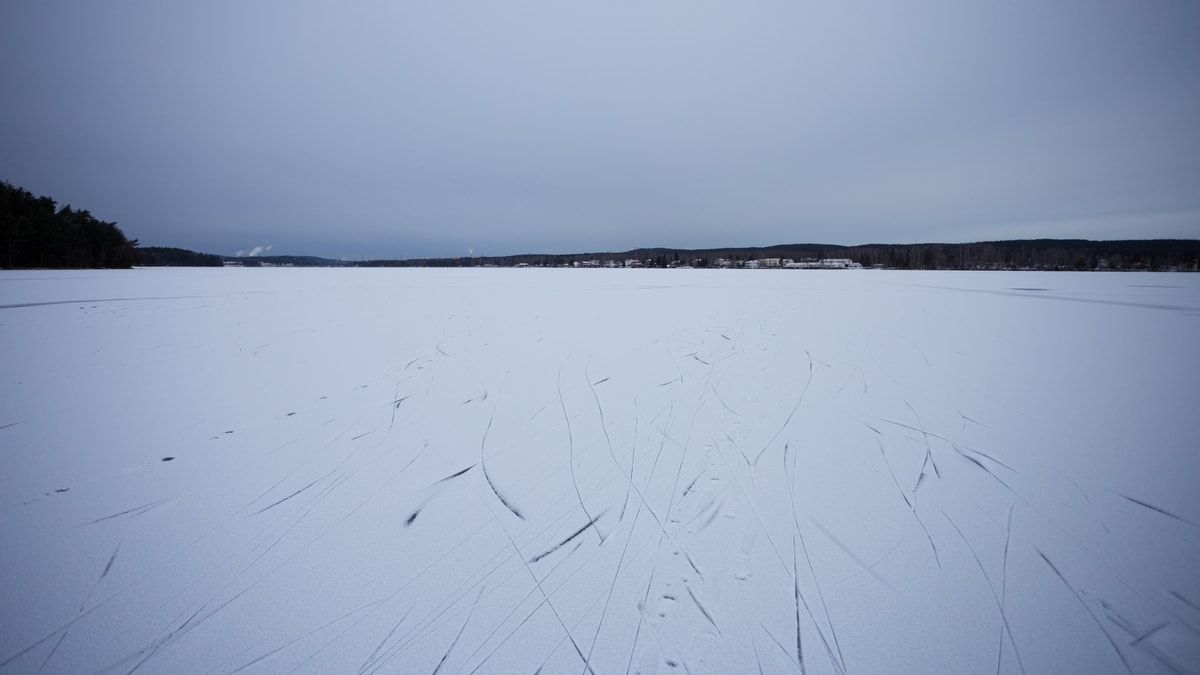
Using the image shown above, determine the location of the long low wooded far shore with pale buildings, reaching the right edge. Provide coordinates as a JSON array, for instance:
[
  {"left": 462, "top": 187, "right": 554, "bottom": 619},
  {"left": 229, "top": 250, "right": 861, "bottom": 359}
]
[{"left": 356, "top": 239, "right": 1200, "bottom": 271}]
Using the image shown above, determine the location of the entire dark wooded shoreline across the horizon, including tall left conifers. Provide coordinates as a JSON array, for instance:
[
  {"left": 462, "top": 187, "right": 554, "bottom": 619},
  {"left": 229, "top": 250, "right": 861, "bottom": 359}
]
[{"left": 7, "top": 181, "right": 1200, "bottom": 271}]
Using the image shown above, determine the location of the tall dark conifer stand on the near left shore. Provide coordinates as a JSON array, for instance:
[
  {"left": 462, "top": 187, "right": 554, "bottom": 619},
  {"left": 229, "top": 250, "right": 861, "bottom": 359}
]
[{"left": 0, "top": 181, "right": 137, "bottom": 269}]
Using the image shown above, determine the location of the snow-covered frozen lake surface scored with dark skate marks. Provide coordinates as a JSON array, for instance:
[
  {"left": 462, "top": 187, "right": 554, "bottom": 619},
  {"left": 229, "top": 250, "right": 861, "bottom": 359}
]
[{"left": 0, "top": 269, "right": 1200, "bottom": 674}]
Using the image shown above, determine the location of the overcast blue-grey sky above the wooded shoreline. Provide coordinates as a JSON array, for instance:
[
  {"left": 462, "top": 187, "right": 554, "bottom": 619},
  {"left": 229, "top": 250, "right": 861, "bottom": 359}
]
[{"left": 0, "top": 0, "right": 1200, "bottom": 258}]
